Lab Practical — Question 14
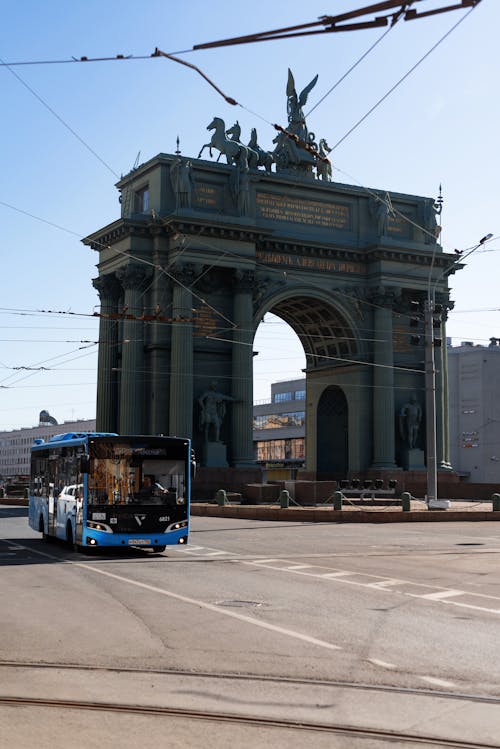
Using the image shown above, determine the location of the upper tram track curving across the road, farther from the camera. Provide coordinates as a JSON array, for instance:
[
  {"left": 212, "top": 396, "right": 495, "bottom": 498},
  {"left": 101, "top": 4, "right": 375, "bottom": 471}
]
[{"left": 0, "top": 660, "right": 500, "bottom": 700}]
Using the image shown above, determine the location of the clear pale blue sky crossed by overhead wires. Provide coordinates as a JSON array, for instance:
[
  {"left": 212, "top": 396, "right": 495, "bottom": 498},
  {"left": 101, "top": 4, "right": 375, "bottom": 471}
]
[{"left": 0, "top": 0, "right": 500, "bottom": 429}]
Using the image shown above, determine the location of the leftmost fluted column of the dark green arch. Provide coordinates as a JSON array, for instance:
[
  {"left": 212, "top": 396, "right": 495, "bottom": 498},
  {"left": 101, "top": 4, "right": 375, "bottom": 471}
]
[{"left": 92, "top": 273, "right": 121, "bottom": 432}]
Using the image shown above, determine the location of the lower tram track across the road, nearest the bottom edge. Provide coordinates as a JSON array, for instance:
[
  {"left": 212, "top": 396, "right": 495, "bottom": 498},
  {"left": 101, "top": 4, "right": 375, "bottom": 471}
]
[{"left": 0, "top": 696, "right": 500, "bottom": 749}]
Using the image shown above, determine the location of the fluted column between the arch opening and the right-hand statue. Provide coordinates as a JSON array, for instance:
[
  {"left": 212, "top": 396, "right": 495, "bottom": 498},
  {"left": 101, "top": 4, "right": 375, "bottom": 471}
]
[{"left": 371, "top": 288, "right": 397, "bottom": 470}]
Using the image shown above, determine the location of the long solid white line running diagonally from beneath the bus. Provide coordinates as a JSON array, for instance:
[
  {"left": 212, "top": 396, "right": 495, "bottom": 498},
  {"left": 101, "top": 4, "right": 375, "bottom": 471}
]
[{"left": 0, "top": 544, "right": 342, "bottom": 650}]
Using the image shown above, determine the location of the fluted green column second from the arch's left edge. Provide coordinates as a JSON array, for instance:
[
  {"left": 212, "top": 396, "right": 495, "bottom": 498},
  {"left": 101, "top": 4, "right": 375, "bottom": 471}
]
[{"left": 116, "top": 263, "right": 151, "bottom": 434}]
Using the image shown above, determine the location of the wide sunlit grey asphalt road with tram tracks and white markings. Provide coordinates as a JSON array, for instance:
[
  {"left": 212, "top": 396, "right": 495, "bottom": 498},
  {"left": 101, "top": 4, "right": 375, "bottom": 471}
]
[{"left": 0, "top": 506, "right": 500, "bottom": 749}]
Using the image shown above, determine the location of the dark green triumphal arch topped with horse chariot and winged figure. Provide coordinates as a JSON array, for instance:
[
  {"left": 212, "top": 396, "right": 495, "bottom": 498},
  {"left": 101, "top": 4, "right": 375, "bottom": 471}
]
[{"left": 84, "top": 72, "right": 456, "bottom": 476}]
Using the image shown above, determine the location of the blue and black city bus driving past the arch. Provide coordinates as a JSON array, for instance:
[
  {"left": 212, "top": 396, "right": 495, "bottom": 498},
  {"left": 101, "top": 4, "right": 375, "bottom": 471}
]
[{"left": 29, "top": 432, "right": 194, "bottom": 552}]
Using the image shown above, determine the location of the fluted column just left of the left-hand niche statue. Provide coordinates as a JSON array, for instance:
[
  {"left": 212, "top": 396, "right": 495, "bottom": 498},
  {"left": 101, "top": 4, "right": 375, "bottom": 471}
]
[{"left": 169, "top": 264, "right": 194, "bottom": 437}]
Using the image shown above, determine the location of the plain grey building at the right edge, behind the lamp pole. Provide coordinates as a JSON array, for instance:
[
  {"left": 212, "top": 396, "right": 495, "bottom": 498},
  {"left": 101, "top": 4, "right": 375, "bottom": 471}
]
[{"left": 448, "top": 338, "right": 500, "bottom": 483}]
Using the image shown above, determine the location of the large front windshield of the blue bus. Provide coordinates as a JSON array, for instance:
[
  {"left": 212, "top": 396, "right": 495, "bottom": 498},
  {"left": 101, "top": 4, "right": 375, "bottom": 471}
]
[{"left": 88, "top": 441, "right": 186, "bottom": 506}]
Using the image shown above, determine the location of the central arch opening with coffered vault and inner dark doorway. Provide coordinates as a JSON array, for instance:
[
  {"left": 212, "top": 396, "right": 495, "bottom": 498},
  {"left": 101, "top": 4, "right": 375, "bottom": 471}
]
[{"left": 254, "top": 294, "right": 361, "bottom": 475}]
